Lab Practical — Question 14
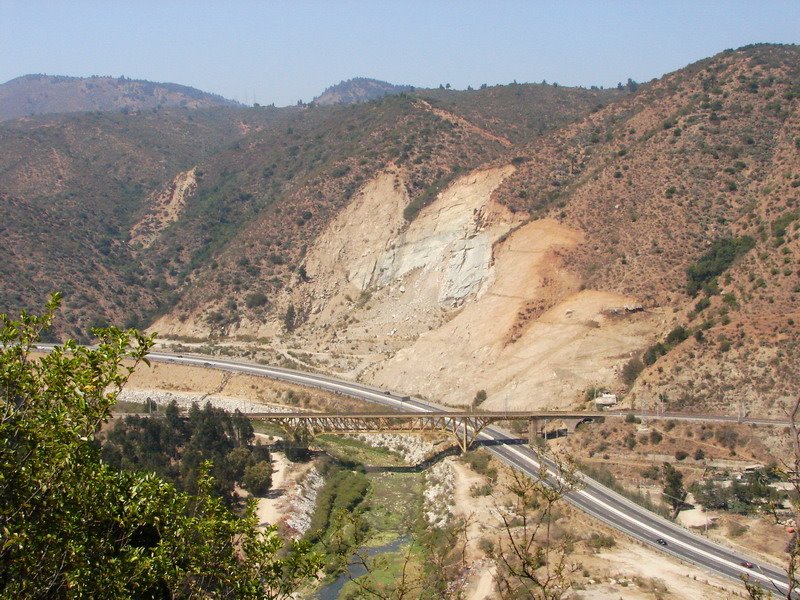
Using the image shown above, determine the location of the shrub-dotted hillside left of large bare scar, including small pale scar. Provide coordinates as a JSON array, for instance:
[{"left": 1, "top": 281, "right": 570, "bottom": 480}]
[{"left": 0, "top": 80, "right": 592, "bottom": 337}]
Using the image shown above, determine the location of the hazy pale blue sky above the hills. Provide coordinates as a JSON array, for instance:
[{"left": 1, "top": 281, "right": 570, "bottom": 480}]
[{"left": 0, "top": 0, "right": 800, "bottom": 106}]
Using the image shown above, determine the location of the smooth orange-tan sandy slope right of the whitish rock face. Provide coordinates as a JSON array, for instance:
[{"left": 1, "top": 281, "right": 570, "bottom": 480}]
[{"left": 374, "top": 221, "right": 658, "bottom": 409}]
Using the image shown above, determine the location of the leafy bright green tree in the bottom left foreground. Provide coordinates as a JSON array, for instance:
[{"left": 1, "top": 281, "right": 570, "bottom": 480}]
[{"left": 0, "top": 294, "right": 320, "bottom": 598}]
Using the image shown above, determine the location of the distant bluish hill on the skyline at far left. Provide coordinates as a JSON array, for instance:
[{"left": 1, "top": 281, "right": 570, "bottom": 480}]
[{"left": 0, "top": 75, "right": 237, "bottom": 121}]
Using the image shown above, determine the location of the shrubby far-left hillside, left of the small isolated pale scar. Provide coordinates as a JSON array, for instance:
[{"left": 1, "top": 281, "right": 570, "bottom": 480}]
[{"left": 0, "top": 108, "right": 292, "bottom": 337}]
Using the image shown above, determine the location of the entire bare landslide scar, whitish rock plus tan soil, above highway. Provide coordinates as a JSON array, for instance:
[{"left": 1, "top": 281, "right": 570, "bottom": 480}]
[{"left": 296, "top": 167, "right": 661, "bottom": 409}]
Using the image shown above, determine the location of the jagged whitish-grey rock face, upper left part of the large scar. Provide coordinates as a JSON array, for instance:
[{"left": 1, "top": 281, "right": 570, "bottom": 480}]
[{"left": 307, "top": 161, "right": 516, "bottom": 313}]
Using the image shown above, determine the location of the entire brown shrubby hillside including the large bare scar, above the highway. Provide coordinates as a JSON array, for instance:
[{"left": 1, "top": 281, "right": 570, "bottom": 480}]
[{"left": 0, "top": 45, "right": 800, "bottom": 414}]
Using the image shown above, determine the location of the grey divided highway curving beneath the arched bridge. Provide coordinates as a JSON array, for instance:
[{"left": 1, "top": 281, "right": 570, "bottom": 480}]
[{"left": 148, "top": 352, "right": 788, "bottom": 597}]
